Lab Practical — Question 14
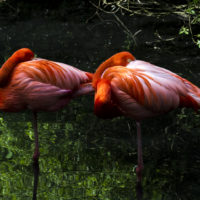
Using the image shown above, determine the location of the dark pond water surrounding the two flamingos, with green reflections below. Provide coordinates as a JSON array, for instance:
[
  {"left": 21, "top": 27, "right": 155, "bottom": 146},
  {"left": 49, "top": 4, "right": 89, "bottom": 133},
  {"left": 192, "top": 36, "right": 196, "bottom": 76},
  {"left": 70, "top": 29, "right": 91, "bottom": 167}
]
[{"left": 0, "top": 0, "right": 200, "bottom": 200}]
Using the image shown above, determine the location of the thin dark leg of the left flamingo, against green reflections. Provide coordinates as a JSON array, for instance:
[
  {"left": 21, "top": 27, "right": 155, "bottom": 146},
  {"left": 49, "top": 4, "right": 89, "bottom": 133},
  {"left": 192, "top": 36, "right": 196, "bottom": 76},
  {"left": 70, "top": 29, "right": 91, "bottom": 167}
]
[{"left": 33, "top": 111, "right": 40, "bottom": 162}]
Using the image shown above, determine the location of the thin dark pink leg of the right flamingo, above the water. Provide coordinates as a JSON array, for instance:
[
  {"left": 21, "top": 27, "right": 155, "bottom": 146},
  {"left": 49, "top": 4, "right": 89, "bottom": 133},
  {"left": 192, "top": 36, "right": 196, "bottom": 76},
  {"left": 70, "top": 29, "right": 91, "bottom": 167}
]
[{"left": 136, "top": 121, "right": 144, "bottom": 183}]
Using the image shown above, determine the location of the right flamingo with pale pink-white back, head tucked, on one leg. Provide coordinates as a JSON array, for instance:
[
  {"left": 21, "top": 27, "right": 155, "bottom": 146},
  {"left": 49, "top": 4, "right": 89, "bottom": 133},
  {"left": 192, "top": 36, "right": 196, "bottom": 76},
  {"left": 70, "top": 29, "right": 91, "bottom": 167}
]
[{"left": 92, "top": 52, "right": 200, "bottom": 185}]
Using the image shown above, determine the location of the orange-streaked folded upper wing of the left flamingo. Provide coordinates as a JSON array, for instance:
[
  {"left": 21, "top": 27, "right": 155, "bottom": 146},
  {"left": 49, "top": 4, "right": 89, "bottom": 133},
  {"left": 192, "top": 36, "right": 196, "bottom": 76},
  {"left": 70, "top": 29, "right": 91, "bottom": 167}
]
[{"left": 14, "top": 59, "right": 90, "bottom": 89}]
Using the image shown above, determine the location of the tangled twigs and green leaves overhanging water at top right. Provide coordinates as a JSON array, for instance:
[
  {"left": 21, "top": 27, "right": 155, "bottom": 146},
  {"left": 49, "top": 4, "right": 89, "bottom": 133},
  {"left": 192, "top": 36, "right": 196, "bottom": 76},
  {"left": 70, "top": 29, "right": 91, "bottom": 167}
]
[{"left": 92, "top": 0, "right": 200, "bottom": 48}]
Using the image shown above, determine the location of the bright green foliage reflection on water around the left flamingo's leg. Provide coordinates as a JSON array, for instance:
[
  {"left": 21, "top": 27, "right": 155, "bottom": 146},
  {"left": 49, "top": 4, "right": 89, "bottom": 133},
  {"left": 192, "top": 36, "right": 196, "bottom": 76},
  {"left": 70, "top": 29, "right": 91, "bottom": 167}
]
[{"left": 0, "top": 110, "right": 138, "bottom": 200}]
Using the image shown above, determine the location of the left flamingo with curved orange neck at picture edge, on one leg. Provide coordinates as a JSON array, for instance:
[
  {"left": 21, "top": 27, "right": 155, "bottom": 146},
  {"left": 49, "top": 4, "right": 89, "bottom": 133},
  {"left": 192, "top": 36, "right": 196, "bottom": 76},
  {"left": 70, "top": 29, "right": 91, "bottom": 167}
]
[{"left": 0, "top": 48, "right": 93, "bottom": 162}]
